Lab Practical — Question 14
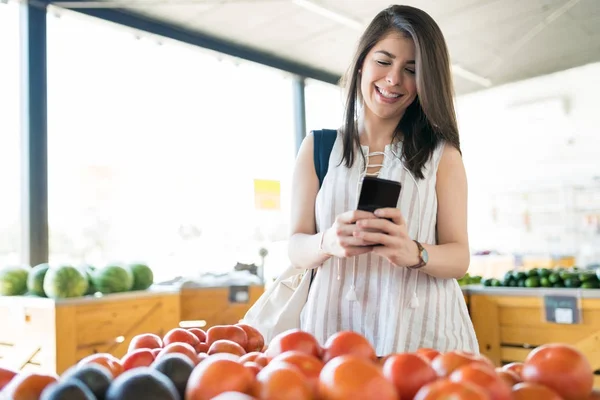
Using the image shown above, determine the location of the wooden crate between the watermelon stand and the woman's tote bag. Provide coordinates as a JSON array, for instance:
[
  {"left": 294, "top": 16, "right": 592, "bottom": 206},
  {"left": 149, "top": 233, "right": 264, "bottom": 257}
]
[{"left": 181, "top": 285, "right": 264, "bottom": 329}]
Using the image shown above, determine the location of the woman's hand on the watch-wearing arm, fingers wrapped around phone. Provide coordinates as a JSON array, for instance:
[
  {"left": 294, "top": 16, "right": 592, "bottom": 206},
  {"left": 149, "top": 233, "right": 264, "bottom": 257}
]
[{"left": 353, "top": 208, "right": 419, "bottom": 267}]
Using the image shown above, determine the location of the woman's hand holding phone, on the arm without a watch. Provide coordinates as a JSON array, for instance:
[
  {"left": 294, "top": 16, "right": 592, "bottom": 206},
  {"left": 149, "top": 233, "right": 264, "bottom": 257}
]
[{"left": 321, "top": 210, "right": 377, "bottom": 258}]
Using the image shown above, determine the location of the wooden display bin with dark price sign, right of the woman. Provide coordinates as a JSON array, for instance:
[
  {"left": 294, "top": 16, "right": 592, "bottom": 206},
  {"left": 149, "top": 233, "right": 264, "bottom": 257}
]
[{"left": 468, "top": 287, "right": 600, "bottom": 387}]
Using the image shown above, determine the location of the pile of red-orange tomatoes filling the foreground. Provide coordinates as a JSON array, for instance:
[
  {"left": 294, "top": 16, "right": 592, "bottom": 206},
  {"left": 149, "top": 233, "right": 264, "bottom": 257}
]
[{"left": 0, "top": 324, "right": 600, "bottom": 400}]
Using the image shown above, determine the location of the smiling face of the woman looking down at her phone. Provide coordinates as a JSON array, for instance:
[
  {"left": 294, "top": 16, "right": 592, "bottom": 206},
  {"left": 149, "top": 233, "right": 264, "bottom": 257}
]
[{"left": 360, "top": 33, "right": 417, "bottom": 120}]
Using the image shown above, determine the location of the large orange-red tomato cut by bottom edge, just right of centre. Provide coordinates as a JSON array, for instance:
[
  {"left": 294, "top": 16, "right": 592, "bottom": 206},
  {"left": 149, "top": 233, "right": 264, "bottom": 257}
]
[{"left": 319, "top": 355, "right": 398, "bottom": 400}]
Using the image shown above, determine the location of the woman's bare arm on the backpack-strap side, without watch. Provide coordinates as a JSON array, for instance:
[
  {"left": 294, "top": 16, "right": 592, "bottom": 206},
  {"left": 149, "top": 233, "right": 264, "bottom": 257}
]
[{"left": 288, "top": 134, "right": 330, "bottom": 268}]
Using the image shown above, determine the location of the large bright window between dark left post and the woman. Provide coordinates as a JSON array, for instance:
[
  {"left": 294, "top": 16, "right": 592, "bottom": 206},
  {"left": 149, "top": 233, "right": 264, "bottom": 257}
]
[{"left": 48, "top": 12, "right": 294, "bottom": 280}]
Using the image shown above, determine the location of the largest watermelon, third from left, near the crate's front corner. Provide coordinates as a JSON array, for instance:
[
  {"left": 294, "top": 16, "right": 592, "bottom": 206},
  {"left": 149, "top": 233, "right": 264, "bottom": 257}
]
[{"left": 44, "top": 265, "right": 88, "bottom": 299}]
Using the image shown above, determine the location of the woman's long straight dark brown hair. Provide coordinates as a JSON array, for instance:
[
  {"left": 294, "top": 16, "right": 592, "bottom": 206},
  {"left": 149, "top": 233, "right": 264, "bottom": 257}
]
[{"left": 342, "top": 5, "right": 460, "bottom": 179}]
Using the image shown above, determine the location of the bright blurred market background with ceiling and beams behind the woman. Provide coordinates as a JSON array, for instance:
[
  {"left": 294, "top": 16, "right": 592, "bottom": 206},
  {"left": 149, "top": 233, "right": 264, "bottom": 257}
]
[{"left": 0, "top": 0, "right": 600, "bottom": 282}]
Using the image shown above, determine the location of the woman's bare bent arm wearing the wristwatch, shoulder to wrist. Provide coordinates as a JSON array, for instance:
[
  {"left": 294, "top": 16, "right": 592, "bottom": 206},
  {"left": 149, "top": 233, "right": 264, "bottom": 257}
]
[{"left": 413, "top": 145, "right": 471, "bottom": 279}]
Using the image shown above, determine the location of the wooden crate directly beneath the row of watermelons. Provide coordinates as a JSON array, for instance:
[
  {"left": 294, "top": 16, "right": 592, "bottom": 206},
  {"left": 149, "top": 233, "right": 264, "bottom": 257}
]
[{"left": 0, "top": 289, "right": 179, "bottom": 374}]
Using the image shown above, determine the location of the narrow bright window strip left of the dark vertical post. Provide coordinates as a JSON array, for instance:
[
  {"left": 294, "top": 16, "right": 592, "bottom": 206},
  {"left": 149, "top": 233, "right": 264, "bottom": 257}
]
[{"left": 0, "top": 1, "right": 21, "bottom": 267}]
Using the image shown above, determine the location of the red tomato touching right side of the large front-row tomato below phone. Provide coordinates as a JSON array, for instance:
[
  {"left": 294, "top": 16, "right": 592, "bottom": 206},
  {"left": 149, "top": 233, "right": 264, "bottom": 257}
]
[{"left": 383, "top": 353, "right": 438, "bottom": 399}]
